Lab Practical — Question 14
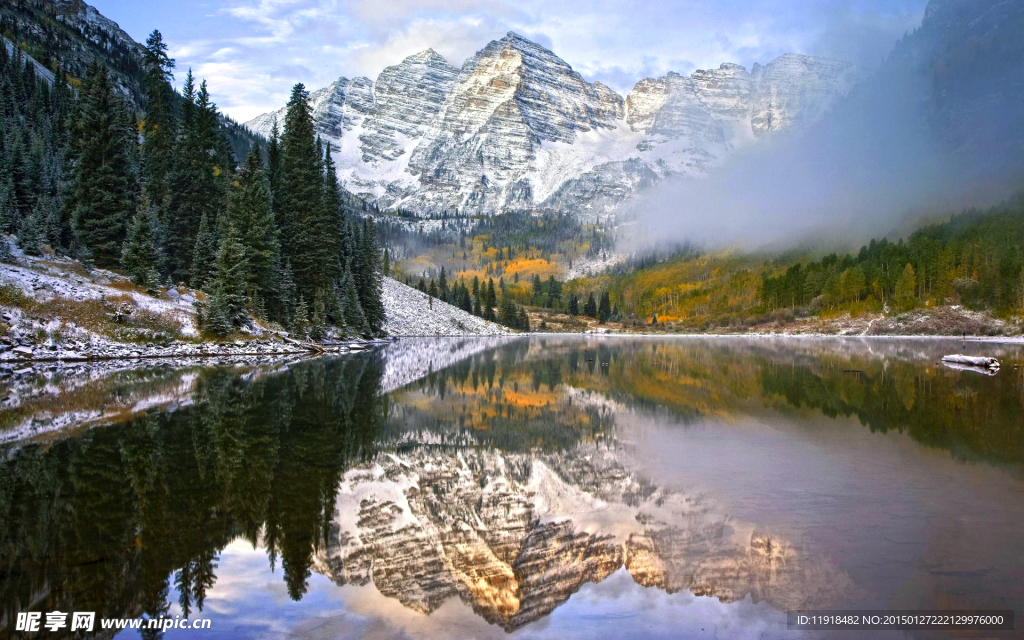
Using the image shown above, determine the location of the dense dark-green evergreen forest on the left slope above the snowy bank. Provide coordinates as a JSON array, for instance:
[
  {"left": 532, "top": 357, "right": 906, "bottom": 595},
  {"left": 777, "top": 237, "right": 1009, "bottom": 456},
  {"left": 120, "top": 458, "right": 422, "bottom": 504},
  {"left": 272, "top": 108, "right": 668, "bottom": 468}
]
[{"left": 0, "top": 31, "right": 384, "bottom": 338}]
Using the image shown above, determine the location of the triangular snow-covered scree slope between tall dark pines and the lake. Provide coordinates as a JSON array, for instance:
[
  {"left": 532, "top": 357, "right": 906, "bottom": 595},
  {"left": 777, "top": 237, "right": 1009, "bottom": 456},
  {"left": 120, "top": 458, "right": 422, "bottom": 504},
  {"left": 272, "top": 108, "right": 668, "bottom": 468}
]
[{"left": 384, "top": 278, "right": 512, "bottom": 337}]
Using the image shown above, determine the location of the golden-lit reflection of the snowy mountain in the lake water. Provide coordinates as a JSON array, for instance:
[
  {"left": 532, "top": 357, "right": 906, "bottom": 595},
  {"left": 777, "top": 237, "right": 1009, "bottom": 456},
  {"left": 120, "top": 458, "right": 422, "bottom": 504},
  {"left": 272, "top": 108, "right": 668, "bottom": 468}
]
[{"left": 316, "top": 445, "right": 849, "bottom": 630}]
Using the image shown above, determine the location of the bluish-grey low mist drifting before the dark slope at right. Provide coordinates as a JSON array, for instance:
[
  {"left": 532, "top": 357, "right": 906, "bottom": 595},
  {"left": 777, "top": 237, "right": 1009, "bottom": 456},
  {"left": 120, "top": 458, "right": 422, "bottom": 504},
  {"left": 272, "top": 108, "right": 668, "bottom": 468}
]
[{"left": 622, "top": 52, "right": 1014, "bottom": 250}]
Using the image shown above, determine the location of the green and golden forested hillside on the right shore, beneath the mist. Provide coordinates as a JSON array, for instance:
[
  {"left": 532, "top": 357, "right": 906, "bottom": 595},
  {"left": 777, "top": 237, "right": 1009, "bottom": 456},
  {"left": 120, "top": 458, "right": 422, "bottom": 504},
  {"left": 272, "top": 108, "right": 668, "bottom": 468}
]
[{"left": 524, "top": 196, "right": 1024, "bottom": 330}]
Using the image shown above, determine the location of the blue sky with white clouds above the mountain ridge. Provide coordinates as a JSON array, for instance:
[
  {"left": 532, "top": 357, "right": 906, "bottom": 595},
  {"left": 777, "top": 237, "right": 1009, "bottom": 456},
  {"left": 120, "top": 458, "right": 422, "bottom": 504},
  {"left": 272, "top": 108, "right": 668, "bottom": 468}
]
[{"left": 90, "top": 0, "right": 927, "bottom": 121}]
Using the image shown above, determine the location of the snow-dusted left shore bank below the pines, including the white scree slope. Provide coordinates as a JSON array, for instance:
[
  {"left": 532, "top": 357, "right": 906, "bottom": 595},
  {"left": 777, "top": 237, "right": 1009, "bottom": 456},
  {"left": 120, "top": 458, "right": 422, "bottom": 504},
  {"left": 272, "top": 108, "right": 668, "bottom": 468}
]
[{"left": 0, "top": 249, "right": 511, "bottom": 372}]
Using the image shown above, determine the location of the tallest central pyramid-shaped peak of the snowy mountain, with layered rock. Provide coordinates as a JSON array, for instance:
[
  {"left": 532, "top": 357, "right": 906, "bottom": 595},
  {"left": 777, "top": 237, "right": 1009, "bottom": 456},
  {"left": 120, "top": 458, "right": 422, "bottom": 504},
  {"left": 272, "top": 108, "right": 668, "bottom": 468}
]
[{"left": 410, "top": 33, "right": 623, "bottom": 211}]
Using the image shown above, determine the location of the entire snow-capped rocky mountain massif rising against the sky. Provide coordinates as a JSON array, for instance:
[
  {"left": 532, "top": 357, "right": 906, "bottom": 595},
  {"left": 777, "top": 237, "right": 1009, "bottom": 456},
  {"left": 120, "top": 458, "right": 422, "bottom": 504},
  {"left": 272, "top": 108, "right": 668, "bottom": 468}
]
[{"left": 247, "top": 33, "right": 858, "bottom": 215}]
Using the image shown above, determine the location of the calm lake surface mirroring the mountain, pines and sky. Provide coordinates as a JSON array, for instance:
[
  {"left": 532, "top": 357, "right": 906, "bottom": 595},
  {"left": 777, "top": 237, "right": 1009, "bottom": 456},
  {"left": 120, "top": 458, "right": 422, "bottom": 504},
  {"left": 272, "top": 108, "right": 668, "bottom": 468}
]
[{"left": 0, "top": 337, "right": 1024, "bottom": 640}]
